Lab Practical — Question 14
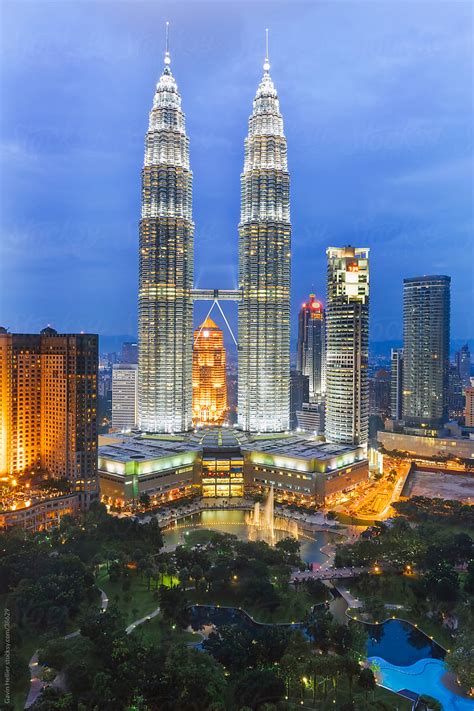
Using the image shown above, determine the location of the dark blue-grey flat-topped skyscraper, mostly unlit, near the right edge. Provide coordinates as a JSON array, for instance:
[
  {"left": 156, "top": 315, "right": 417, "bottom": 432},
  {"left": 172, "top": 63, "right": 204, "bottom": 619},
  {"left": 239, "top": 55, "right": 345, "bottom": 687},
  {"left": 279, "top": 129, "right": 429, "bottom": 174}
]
[{"left": 403, "top": 276, "right": 451, "bottom": 427}]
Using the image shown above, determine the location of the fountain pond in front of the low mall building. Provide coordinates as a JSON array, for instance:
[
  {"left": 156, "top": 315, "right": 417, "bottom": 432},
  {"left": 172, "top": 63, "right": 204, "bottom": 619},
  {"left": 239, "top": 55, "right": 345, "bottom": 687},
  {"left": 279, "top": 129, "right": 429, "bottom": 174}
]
[{"left": 163, "top": 509, "right": 339, "bottom": 563}]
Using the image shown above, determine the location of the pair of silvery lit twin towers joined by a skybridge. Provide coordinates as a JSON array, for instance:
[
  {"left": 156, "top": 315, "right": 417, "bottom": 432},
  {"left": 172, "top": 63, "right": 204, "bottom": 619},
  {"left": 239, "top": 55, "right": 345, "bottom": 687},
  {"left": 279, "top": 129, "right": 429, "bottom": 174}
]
[{"left": 139, "top": 33, "right": 291, "bottom": 432}]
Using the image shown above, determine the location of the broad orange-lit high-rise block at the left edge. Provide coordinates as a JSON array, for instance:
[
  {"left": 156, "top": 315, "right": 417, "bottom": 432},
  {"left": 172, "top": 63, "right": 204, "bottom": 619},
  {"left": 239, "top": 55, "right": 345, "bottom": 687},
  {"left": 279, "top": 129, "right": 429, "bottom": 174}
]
[{"left": 0, "top": 327, "right": 98, "bottom": 481}]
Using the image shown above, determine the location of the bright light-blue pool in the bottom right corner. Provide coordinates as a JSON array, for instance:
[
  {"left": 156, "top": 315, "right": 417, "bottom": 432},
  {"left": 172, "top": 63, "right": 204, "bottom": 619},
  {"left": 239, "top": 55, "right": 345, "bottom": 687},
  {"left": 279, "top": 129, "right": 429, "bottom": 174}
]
[{"left": 369, "top": 657, "right": 474, "bottom": 711}]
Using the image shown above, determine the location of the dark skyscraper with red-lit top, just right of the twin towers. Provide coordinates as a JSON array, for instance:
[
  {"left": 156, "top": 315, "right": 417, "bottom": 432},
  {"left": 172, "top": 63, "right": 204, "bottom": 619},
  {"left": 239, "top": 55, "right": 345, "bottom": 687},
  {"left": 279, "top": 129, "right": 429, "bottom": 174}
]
[{"left": 296, "top": 294, "right": 326, "bottom": 402}]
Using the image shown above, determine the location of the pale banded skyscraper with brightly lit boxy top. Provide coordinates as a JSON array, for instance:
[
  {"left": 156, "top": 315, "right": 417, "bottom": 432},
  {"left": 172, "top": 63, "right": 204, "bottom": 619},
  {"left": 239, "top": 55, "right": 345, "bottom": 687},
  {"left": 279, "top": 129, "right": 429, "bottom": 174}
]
[{"left": 326, "top": 247, "right": 369, "bottom": 445}]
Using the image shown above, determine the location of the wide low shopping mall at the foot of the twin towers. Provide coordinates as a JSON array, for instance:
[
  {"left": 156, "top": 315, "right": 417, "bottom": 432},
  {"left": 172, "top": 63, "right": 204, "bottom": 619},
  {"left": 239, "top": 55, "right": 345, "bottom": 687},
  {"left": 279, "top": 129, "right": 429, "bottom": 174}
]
[{"left": 99, "top": 427, "right": 368, "bottom": 506}]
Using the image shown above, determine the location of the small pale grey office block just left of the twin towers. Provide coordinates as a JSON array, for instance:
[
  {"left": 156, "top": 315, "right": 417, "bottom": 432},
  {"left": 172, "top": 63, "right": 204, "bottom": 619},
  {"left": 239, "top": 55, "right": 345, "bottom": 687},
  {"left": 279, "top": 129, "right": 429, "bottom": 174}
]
[{"left": 112, "top": 363, "right": 138, "bottom": 430}]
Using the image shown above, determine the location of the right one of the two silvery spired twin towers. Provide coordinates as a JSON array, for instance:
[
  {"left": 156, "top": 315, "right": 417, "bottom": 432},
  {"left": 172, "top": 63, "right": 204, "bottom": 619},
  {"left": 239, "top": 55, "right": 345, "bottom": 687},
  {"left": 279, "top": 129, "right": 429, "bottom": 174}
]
[{"left": 238, "top": 40, "right": 291, "bottom": 432}]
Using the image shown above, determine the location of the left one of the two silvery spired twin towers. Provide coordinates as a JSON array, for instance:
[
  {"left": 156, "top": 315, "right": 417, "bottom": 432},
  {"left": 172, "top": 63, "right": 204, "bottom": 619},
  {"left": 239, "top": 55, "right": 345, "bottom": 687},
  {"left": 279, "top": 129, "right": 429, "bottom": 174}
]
[{"left": 138, "top": 34, "right": 194, "bottom": 432}]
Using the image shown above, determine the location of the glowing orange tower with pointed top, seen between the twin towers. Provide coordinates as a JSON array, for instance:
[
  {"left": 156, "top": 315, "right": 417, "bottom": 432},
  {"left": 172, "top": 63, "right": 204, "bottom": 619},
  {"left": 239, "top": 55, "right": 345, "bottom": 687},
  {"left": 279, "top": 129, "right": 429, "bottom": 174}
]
[{"left": 193, "top": 316, "right": 227, "bottom": 425}]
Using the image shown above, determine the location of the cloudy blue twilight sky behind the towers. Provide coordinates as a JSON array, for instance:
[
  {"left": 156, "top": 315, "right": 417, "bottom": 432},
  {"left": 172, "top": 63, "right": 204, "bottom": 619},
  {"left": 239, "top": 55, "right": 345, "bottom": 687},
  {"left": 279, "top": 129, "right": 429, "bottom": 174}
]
[{"left": 0, "top": 0, "right": 474, "bottom": 340}]
